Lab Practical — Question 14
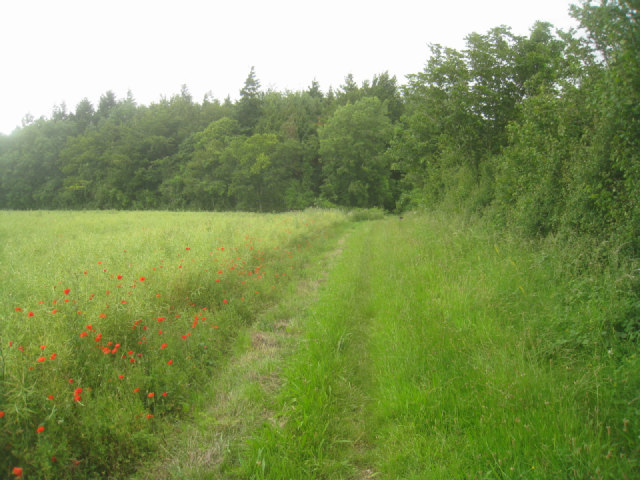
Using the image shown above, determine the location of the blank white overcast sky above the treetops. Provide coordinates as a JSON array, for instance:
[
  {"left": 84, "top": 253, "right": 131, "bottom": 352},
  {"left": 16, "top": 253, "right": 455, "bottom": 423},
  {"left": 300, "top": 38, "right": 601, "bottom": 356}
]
[{"left": 0, "top": 0, "right": 578, "bottom": 134}]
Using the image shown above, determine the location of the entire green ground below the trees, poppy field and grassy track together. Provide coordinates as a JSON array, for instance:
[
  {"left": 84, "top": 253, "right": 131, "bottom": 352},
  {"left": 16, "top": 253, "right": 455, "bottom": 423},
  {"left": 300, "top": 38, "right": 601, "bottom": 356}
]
[{"left": 0, "top": 210, "right": 640, "bottom": 480}]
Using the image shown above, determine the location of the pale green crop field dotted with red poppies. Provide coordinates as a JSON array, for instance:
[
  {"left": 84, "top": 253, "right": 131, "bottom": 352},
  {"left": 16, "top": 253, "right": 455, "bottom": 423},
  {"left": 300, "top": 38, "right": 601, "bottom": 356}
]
[{"left": 0, "top": 211, "right": 345, "bottom": 479}]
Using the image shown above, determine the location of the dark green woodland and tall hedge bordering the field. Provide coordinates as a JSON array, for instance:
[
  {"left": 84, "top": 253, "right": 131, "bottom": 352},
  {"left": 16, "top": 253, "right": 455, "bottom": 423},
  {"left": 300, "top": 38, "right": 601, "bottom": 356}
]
[{"left": 0, "top": 0, "right": 640, "bottom": 253}]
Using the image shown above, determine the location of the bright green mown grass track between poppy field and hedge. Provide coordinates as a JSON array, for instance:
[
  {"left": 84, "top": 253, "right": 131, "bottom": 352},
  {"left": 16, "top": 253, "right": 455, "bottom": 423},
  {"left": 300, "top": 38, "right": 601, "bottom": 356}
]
[{"left": 136, "top": 215, "right": 639, "bottom": 479}]
